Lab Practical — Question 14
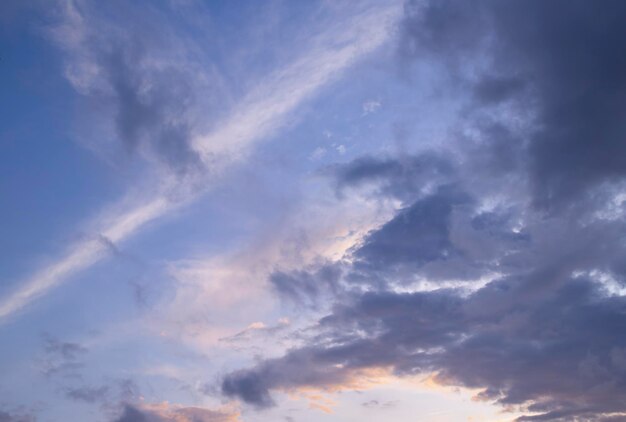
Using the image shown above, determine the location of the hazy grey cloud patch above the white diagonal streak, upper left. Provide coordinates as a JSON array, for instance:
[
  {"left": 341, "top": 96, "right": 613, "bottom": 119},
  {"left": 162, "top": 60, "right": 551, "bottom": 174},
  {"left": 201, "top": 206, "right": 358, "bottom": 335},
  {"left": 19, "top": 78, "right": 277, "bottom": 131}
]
[{"left": 55, "top": 2, "right": 219, "bottom": 173}]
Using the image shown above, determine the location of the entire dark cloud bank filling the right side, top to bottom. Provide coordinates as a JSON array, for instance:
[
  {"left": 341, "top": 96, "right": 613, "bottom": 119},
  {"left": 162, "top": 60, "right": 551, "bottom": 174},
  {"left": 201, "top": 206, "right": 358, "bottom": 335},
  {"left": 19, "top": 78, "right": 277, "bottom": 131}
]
[{"left": 222, "top": 0, "right": 626, "bottom": 420}]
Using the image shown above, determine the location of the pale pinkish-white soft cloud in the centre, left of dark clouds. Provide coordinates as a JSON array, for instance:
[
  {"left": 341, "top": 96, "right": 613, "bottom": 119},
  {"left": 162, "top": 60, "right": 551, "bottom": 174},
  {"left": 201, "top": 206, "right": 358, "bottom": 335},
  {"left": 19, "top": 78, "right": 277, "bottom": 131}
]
[{"left": 146, "top": 176, "right": 388, "bottom": 352}]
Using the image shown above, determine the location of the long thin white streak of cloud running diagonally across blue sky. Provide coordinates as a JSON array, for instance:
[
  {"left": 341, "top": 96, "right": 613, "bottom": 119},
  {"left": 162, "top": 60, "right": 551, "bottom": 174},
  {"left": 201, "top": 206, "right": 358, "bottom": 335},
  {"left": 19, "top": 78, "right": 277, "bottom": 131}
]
[{"left": 0, "top": 2, "right": 400, "bottom": 321}]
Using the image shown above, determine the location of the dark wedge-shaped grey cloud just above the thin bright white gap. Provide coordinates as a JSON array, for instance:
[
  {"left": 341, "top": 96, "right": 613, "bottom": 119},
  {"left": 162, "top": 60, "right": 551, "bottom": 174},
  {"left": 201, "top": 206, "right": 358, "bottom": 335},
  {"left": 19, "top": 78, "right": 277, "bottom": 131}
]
[{"left": 347, "top": 180, "right": 529, "bottom": 287}]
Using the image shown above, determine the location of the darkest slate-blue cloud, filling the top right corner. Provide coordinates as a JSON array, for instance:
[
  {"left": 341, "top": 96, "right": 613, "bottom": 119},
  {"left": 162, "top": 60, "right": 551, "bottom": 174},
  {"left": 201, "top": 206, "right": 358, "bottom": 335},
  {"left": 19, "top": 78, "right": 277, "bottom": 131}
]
[{"left": 401, "top": 0, "right": 626, "bottom": 210}]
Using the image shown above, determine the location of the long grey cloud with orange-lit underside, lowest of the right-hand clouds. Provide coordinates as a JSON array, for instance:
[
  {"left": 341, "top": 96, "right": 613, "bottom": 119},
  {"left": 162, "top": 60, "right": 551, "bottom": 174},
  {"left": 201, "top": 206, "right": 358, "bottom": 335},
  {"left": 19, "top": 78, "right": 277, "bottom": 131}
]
[{"left": 223, "top": 274, "right": 626, "bottom": 420}]
